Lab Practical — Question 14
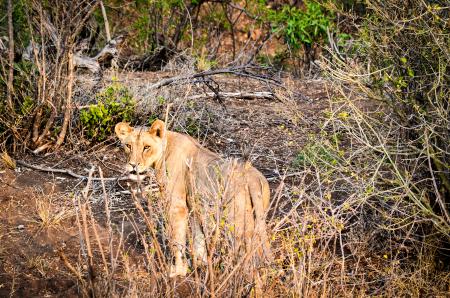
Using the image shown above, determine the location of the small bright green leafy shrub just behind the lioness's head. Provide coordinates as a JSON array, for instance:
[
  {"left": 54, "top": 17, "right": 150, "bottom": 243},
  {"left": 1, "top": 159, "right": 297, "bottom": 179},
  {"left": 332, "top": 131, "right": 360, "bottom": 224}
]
[{"left": 80, "top": 83, "right": 135, "bottom": 141}]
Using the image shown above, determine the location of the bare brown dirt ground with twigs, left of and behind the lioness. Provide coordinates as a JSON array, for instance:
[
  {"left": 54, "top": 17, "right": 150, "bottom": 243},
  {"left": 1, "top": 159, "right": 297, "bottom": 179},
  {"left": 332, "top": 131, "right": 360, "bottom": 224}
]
[{"left": 0, "top": 73, "right": 328, "bottom": 297}]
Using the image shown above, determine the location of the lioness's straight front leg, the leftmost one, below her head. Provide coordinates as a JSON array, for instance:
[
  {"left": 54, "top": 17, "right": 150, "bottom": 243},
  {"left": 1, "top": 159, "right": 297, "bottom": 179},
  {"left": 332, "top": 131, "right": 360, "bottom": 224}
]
[{"left": 169, "top": 198, "right": 188, "bottom": 277}]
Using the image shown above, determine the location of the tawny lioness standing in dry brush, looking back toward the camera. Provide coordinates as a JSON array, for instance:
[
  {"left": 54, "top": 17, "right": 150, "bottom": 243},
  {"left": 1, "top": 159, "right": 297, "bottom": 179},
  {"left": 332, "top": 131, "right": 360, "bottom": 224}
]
[{"left": 115, "top": 120, "right": 271, "bottom": 277}]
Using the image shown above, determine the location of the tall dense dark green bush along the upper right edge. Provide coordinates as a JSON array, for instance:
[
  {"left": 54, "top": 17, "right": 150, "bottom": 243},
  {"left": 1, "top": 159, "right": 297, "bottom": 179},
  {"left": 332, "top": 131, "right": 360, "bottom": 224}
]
[{"left": 361, "top": 0, "right": 450, "bottom": 200}]
